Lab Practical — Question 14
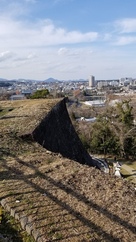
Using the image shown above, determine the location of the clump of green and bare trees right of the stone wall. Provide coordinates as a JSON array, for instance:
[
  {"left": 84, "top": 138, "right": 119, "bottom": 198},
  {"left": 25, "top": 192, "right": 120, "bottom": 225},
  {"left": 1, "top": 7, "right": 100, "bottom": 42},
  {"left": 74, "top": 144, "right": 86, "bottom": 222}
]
[{"left": 72, "top": 100, "right": 136, "bottom": 159}]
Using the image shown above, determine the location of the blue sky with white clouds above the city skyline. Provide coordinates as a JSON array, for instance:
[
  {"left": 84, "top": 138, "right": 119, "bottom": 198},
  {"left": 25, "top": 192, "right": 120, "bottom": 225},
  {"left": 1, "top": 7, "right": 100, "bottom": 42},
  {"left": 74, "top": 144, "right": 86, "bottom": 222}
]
[{"left": 0, "top": 0, "right": 136, "bottom": 80}]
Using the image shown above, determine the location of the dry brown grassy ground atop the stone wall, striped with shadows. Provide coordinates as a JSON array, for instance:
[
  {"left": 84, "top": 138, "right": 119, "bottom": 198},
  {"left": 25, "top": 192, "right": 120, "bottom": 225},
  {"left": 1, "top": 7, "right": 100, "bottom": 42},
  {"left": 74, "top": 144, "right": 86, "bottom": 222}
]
[{"left": 0, "top": 100, "right": 136, "bottom": 242}]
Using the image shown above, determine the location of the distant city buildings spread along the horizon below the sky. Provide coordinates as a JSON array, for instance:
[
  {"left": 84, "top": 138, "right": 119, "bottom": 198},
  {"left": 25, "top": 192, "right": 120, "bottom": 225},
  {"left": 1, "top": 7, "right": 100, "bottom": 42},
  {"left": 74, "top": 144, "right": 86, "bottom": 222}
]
[{"left": 0, "top": 75, "right": 136, "bottom": 100}]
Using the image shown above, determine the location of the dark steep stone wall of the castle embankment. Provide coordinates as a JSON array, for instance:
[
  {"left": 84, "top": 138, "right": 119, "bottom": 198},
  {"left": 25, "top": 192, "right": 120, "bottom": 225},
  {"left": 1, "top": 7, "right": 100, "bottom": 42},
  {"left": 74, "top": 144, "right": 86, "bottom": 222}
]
[{"left": 32, "top": 98, "right": 95, "bottom": 166}]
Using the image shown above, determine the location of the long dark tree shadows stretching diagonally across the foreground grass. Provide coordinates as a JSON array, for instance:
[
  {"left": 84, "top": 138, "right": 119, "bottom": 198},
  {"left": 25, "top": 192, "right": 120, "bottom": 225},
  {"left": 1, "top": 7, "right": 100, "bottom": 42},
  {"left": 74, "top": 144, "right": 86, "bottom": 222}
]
[{"left": 1, "top": 156, "right": 135, "bottom": 242}]
